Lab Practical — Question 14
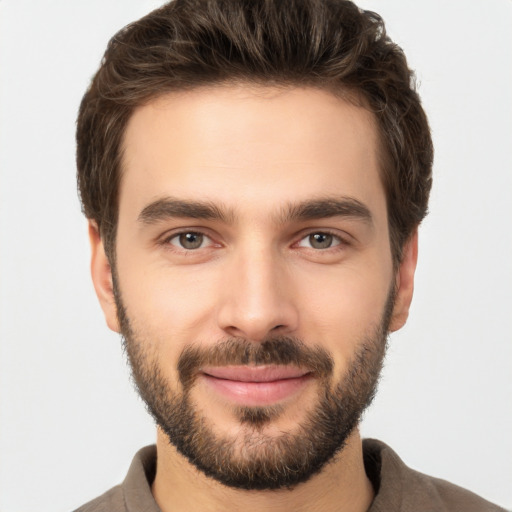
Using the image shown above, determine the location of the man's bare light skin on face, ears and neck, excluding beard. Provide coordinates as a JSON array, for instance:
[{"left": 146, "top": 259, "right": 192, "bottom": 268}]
[{"left": 90, "top": 85, "right": 417, "bottom": 512}]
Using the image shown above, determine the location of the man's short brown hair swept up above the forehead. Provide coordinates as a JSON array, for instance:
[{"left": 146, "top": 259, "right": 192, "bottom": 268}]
[{"left": 76, "top": 0, "right": 433, "bottom": 264}]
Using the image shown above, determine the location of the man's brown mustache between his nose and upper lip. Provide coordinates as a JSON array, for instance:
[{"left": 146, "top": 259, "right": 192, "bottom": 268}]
[{"left": 178, "top": 336, "right": 334, "bottom": 390}]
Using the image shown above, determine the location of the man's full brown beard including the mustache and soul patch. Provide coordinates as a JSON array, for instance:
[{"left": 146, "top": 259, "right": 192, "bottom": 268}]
[{"left": 114, "top": 279, "right": 394, "bottom": 490}]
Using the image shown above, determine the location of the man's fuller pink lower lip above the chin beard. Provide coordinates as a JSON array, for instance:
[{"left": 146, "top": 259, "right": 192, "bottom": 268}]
[{"left": 202, "top": 374, "right": 312, "bottom": 407}]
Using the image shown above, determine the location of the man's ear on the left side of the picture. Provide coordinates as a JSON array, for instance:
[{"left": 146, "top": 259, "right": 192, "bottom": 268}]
[{"left": 89, "top": 220, "right": 120, "bottom": 332}]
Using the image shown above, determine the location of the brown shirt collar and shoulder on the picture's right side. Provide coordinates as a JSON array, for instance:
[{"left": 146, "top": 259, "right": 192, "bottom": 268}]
[{"left": 363, "top": 439, "right": 506, "bottom": 512}]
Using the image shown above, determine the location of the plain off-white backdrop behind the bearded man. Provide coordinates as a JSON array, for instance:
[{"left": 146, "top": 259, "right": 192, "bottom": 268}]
[{"left": 0, "top": 0, "right": 512, "bottom": 512}]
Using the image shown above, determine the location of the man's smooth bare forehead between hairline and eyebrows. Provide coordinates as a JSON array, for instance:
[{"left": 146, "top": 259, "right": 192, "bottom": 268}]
[{"left": 119, "top": 86, "right": 384, "bottom": 223}]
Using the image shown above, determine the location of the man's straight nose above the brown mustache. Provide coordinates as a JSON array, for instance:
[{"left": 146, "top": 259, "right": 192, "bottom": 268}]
[{"left": 218, "top": 243, "right": 299, "bottom": 342}]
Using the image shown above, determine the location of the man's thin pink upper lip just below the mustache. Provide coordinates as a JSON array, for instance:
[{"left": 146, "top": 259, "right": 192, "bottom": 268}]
[{"left": 201, "top": 365, "right": 310, "bottom": 382}]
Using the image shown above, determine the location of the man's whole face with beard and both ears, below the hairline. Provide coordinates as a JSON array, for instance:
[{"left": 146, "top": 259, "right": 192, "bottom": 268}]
[{"left": 91, "top": 86, "right": 416, "bottom": 489}]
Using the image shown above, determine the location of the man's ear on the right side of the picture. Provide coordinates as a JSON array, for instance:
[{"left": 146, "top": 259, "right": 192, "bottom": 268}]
[{"left": 389, "top": 230, "right": 418, "bottom": 332}]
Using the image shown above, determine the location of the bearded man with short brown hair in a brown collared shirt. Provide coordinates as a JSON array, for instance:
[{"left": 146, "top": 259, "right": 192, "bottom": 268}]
[{"left": 72, "top": 0, "right": 499, "bottom": 512}]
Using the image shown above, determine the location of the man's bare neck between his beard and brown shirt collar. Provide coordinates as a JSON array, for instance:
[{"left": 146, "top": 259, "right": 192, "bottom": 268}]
[{"left": 152, "top": 430, "right": 374, "bottom": 512}]
